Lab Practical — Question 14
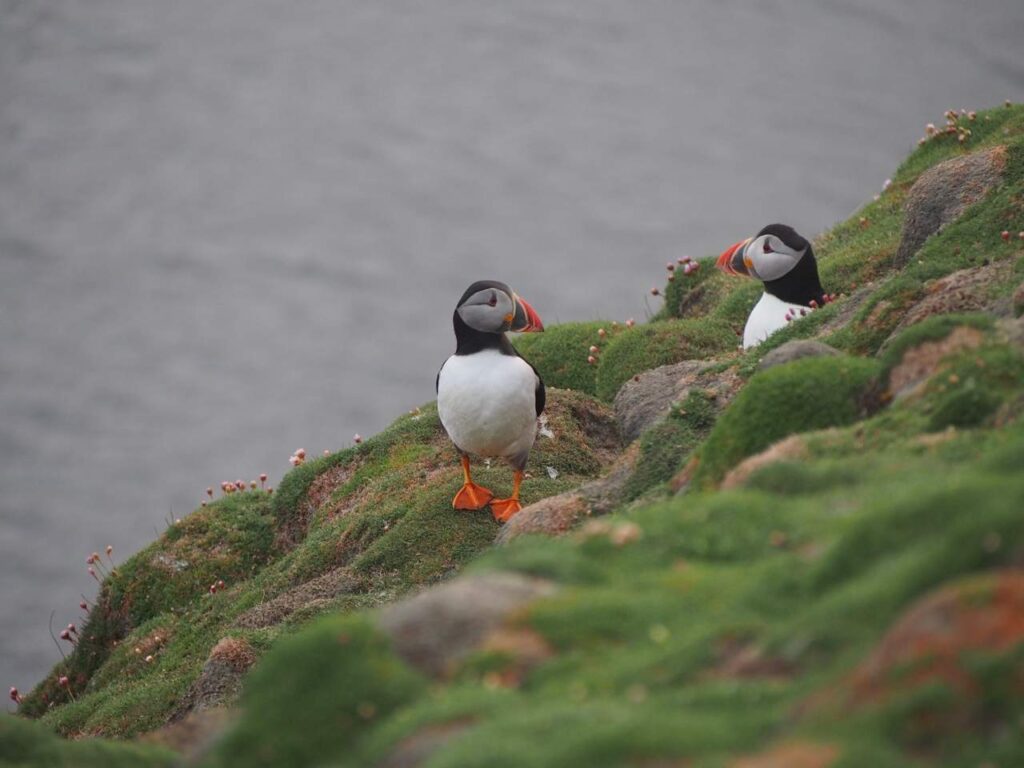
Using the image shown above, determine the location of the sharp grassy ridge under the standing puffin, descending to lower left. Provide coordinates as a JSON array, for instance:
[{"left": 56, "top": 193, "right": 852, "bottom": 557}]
[{"left": 19, "top": 389, "right": 616, "bottom": 736}]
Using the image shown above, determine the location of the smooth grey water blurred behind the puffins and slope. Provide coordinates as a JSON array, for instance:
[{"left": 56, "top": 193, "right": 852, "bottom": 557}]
[{"left": 0, "top": 0, "right": 1024, "bottom": 689}]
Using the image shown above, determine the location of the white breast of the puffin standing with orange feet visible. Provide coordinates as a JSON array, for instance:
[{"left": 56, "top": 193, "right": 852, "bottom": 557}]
[{"left": 437, "top": 349, "right": 538, "bottom": 457}]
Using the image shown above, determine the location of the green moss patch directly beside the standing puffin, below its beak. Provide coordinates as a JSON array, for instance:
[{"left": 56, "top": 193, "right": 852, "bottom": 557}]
[{"left": 514, "top": 321, "right": 620, "bottom": 395}]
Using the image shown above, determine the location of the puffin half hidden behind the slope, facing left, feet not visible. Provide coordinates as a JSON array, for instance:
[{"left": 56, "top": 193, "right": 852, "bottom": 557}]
[{"left": 716, "top": 224, "right": 831, "bottom": 349}]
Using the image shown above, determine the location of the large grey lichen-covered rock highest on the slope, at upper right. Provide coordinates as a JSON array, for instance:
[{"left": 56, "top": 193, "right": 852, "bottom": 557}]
[{"left": 895, "top": 146, "right": 1007, "bottom": 266}]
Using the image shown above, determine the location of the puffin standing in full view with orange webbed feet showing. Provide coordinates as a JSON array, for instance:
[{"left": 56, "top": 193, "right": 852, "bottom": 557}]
[{"left": 435, "top": 280, "right": 545, "bottom": 522}]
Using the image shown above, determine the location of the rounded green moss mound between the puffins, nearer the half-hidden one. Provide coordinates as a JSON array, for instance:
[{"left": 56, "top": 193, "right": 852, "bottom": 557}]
[{"left": 597, "top": 319, "right": 737, "bottom": 401}]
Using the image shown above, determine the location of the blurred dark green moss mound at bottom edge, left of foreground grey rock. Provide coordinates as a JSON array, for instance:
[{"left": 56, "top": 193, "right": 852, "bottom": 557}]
[{"left": 208, "top": 617, "right": 425, "bottom": 767}]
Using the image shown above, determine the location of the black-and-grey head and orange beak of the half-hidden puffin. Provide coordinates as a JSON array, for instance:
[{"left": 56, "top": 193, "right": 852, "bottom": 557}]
[{"left": 717, "top": 224, "right": 824, "bottom": 305}]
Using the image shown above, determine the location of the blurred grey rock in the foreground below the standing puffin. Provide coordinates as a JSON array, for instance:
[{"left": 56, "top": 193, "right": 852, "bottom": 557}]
[{"left": 378, "top": 572, "right": 555, "bottom": 677}]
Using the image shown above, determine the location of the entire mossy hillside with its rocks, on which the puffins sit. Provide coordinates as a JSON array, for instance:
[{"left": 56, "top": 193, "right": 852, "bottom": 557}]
[{"left": 8, "top": 105, "right": 1024, "bottom": 768}]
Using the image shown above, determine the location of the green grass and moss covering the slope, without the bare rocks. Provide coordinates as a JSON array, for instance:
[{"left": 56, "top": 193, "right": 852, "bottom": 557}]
[{"left": 8, "top": 106, "right": 1024, "bottom": 766}]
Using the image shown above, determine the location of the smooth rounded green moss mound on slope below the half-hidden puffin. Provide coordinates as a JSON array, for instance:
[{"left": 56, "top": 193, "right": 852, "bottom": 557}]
[{"left": 693, "top": 356, "right": 879, "bottom": 486}]
